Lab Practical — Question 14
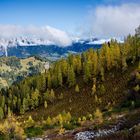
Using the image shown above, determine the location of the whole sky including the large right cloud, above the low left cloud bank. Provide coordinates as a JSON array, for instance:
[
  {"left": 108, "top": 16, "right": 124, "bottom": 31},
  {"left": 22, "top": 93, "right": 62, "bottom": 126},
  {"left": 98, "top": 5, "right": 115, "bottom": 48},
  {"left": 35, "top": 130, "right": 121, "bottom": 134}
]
[{"left": 0, "top": 0, "right": 140, "bottom": 37}]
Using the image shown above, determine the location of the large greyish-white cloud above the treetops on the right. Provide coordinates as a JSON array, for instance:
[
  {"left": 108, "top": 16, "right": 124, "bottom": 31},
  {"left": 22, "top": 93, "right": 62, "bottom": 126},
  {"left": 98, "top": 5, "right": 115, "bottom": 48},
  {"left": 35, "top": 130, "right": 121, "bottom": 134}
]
[{"left": 88, "top": 3, "right": 140, "bottom": 38}]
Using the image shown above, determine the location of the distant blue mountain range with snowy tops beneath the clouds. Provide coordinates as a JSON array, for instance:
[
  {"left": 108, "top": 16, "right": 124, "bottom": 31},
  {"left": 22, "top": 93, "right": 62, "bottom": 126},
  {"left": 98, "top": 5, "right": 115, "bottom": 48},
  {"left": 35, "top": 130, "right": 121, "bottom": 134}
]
[{"left": 0, "top": 37, "right": 123, "bottom": 60}]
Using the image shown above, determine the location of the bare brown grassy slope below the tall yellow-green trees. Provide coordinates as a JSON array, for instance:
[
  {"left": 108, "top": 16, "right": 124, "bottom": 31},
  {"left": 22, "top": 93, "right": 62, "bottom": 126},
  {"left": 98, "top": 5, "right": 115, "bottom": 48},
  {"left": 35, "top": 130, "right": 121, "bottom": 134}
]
[{"left": 24, "top": 61, "right": 137, "bottom": 121}]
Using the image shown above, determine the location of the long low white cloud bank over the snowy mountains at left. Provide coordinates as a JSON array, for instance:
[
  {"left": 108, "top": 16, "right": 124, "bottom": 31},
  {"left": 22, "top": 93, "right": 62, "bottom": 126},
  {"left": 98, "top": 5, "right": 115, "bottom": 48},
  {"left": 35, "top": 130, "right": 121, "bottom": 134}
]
[{"left": 0, "top": 25, "right": 72, "bottom": 46}]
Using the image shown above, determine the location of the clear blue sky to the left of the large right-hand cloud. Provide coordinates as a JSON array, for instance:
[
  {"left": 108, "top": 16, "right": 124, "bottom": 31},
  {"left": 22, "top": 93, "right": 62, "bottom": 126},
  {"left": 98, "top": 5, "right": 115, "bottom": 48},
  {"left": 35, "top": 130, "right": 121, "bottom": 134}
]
[{"left": 0, "top": 0, "right": 92, "bottom": 29}]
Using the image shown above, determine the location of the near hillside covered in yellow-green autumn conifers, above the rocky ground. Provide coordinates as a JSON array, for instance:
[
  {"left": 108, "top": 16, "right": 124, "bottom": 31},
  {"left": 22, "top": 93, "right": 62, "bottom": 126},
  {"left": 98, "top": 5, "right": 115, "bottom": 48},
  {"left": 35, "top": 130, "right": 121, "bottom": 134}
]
[{"left": 0, "top": 27, "right": 140, "bottom": 138}]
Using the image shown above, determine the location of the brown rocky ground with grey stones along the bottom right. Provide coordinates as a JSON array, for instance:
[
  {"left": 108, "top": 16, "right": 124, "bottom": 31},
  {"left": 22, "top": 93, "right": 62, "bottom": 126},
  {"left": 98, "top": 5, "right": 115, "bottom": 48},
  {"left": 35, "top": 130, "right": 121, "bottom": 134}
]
[{"left": 27, "top": 111, "right": 140, "bottom": 140}]
